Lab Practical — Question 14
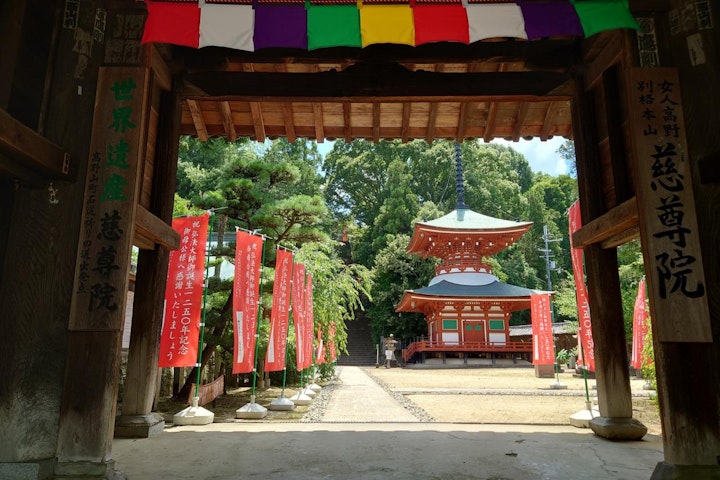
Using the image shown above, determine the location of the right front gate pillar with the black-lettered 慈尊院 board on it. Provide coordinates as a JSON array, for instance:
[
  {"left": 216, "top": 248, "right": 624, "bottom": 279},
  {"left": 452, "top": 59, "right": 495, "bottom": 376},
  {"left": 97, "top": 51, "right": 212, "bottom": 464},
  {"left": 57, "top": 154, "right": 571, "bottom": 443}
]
[{"left": 626, "top": 67, "right": 720, "bottom": 480}]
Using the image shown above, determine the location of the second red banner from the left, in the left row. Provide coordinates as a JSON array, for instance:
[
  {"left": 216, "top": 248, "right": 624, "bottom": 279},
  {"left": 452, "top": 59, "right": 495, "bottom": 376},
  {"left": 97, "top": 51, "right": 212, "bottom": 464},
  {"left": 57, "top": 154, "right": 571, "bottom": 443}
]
[{"left": 233, "top": 231, "right": 263, "bottom": 373}]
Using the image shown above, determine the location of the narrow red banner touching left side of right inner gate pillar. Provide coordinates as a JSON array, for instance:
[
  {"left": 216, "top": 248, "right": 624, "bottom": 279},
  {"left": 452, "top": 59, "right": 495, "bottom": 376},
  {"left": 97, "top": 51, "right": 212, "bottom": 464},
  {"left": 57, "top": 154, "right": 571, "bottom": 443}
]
[{"left": 568, "top": 200, "right": 595, "bottom": 372}]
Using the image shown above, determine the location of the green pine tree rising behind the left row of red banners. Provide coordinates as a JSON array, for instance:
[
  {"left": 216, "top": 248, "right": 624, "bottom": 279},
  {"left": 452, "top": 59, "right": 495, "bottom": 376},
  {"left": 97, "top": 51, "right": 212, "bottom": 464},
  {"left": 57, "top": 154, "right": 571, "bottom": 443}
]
[{"left": 173, "top": 138, "right": 336, "bottom": 395}]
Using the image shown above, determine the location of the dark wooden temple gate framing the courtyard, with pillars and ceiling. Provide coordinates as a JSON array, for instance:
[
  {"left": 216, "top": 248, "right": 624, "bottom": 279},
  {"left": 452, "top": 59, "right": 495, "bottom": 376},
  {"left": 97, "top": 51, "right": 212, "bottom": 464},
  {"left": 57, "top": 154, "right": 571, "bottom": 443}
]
[{"left": 0, "top": 0, "right": 720, "bottom": 479}]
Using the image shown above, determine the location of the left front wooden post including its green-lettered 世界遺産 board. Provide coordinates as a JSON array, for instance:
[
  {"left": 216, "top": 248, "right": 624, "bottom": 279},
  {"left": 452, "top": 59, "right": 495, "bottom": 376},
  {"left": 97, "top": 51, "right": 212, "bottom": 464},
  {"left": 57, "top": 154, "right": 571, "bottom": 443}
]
[{"left": 55, "top": 67, "right": 150, "bottom": 477}]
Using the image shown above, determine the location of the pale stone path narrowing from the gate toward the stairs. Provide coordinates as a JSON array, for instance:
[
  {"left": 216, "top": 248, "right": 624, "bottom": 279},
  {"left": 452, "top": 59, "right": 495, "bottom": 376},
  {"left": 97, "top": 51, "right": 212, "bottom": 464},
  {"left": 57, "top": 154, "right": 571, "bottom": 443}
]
[{"left": 322, "top": 367, "right": 420, "bottom": 423}]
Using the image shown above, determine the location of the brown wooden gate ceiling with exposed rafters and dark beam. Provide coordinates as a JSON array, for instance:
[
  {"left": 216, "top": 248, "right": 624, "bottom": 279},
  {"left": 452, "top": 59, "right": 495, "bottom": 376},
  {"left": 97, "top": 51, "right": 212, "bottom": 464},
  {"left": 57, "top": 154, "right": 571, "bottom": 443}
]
[{"left": 172, "top": 38, "right": 580, "bottom": 142}]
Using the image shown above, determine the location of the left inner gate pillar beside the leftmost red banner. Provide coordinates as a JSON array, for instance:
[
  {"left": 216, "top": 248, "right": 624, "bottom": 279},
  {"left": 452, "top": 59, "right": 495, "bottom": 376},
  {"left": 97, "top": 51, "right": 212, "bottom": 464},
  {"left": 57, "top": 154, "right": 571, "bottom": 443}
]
[{"left": 115, "top": 56, "right": 181, "bottom": 438}]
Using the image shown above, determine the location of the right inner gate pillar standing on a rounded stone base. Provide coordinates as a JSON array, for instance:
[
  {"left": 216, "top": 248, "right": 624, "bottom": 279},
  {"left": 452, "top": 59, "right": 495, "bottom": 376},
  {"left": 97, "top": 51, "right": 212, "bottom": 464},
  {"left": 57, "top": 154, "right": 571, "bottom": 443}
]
[{"left": 573, "top": 32, "right": 647, "bottom": 440}]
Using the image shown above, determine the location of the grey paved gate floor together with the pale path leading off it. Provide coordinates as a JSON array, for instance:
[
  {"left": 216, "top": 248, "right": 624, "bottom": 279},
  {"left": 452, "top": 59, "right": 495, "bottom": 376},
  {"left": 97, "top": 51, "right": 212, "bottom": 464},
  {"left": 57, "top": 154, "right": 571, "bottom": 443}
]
[{"left": 112, "top": 367, "right": 663, "bottom": 480}]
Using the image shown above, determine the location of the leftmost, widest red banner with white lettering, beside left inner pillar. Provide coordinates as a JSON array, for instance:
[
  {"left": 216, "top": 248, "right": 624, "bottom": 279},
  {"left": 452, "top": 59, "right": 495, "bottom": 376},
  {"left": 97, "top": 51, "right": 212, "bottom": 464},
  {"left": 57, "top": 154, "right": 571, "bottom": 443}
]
[{"left": 158, "top": 214, "right": 210, "bottom": 367}]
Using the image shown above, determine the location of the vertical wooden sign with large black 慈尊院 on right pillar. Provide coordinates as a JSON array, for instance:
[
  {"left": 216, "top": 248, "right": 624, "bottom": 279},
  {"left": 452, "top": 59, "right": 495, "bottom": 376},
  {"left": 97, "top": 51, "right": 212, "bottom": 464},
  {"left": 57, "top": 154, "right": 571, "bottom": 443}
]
[{"left": 627, "top": 68, "right": 712, "bottom": 342}]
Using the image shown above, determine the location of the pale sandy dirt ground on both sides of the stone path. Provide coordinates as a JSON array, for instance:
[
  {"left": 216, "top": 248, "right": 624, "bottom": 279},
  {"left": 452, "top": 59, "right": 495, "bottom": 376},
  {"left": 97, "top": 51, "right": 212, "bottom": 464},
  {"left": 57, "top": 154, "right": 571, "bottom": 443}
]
[{"left": 158, "top": 367, "right": 661, "bottom": 435}]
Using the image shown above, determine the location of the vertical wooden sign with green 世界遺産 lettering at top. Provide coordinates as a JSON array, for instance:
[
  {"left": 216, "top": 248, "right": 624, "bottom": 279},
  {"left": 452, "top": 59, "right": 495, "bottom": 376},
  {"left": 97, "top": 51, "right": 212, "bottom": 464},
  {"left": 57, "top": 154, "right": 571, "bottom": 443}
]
[{"left": 69, "top": 67, "right": 148, "bottom": 331}]
